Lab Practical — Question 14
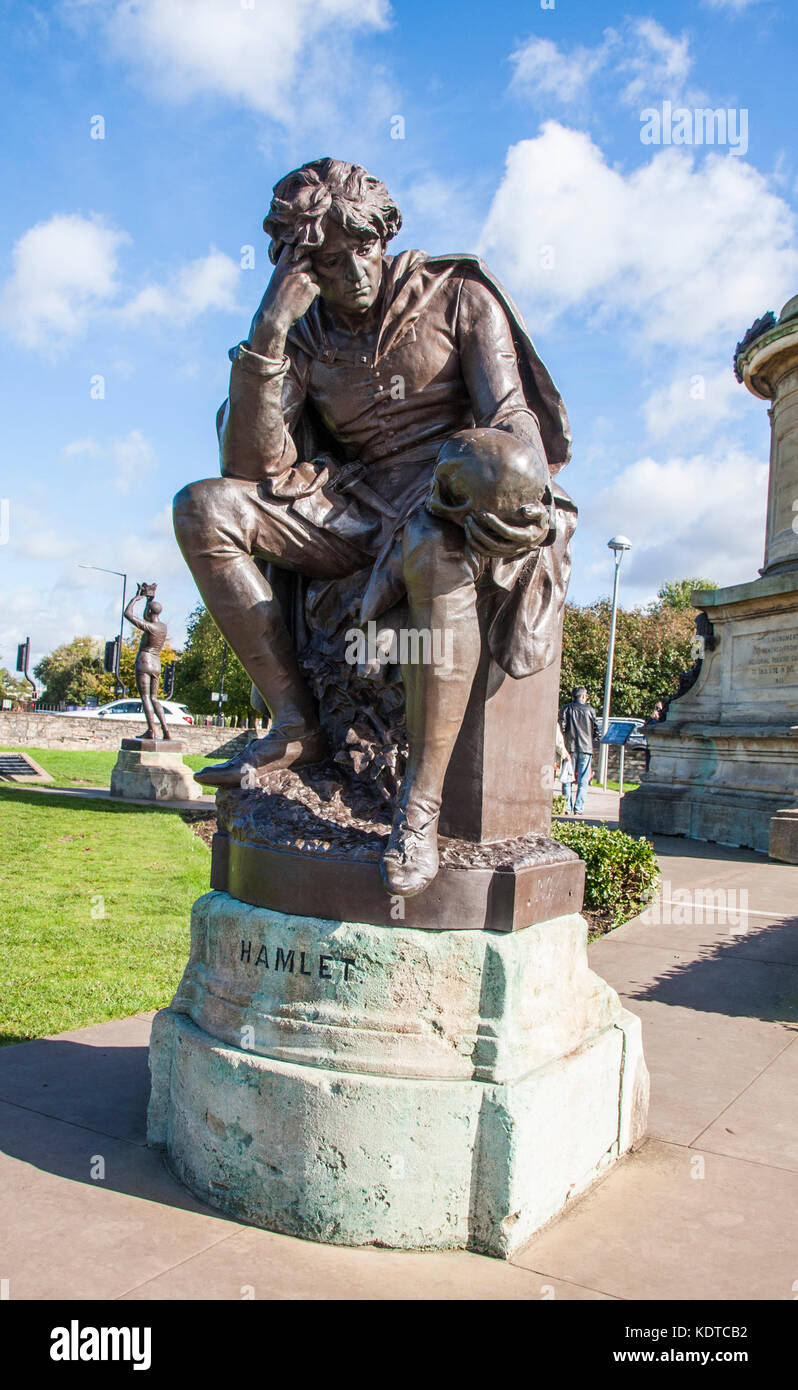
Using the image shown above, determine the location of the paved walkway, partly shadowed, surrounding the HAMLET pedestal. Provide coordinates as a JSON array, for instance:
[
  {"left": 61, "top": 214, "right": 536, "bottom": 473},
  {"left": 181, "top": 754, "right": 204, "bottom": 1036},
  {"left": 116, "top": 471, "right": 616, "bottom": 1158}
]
[{"left": 0, "top": 838, "right": 798, "bottom": 1301}]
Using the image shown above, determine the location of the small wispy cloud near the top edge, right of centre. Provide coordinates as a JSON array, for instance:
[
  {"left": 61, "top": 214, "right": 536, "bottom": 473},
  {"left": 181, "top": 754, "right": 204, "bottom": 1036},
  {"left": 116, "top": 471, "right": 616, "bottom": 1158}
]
[{"left": 510, "top": 19, "right": 692, "bottom": 106}]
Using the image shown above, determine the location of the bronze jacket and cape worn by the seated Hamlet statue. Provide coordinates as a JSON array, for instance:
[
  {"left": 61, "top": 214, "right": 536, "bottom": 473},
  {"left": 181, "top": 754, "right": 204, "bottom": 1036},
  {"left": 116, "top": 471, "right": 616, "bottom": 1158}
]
[{"left": 218, "top": 252, "right": 576, "bottom": 677}]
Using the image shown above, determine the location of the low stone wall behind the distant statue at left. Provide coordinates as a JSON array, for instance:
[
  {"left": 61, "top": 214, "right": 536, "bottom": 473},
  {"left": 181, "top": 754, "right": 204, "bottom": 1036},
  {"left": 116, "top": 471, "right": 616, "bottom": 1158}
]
[{"left": 0, "top": 710, "right": 255, "bottom": 758}]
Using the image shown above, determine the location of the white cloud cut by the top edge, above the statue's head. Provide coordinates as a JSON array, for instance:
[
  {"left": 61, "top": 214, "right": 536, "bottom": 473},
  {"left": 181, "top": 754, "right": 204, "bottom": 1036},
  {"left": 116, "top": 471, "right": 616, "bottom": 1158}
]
[{"left": 70, "top": 0, "right": 389, "bottom": 125}]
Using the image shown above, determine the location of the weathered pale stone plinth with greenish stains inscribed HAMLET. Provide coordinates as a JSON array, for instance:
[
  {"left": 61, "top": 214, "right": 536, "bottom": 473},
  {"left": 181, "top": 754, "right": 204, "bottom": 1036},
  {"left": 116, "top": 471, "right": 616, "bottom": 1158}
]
[{"left": 149, "top": 892, "right": 648, "bottom": 1257}]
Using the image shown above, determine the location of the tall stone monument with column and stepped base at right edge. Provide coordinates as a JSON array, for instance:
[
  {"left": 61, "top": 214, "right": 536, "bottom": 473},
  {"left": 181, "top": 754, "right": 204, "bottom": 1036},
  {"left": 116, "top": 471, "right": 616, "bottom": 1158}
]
[{"left": 620, "top": 296, "right": 798, "bottom": 863}]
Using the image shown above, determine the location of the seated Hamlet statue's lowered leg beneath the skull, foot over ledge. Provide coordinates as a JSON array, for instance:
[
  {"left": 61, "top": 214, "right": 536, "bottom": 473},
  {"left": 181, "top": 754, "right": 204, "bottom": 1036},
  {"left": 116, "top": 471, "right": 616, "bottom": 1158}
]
[{"left": 382, "top": 512, "right": 481, "bottom": 897}]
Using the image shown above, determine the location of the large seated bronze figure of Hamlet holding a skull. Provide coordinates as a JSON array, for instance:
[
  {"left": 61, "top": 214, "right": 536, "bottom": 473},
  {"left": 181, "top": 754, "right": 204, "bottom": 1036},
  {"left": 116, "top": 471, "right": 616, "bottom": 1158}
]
[{"left": 175, "top": 158, "right": 576, "bottom": 897}]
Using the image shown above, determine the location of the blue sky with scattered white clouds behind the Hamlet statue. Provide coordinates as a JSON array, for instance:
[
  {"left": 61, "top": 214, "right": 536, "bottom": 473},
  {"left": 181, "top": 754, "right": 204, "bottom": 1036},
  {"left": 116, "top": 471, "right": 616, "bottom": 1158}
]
[{"left": 0, "top": 0, "right": 798, "bottom": 667}]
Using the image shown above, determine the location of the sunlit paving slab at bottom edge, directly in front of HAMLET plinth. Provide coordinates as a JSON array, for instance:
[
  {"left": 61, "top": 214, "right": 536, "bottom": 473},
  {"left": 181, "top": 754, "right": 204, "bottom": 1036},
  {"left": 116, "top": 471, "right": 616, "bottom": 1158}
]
[{"left": 118, "top": 1227, "right": 617, "bottom": 1302}]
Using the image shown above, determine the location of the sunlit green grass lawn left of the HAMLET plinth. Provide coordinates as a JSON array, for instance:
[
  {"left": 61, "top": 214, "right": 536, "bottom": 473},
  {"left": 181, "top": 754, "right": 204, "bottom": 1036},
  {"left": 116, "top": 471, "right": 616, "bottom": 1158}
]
[{"left": 0, "top": 789, "right": 210, "bottom": 1045}]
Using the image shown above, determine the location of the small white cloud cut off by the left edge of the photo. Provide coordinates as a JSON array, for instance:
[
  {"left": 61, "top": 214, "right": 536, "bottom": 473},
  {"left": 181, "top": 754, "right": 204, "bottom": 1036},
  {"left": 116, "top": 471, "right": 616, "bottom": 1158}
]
[{"left": 0, "top": 213, "right": 129, "bottom": 354}]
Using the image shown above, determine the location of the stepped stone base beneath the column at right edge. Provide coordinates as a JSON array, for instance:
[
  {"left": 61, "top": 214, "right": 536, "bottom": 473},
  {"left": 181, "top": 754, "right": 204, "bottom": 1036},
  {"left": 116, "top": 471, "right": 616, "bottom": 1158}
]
[{"left": 620, "top": 571, "right": 798, "bottom": 863}]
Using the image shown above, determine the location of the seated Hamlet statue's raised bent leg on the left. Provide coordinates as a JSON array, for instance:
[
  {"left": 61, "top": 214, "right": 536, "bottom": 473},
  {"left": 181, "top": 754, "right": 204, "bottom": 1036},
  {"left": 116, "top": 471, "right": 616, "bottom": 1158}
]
[{"left": 174, "top": 478, "right": 366, "bottom": 785}]
